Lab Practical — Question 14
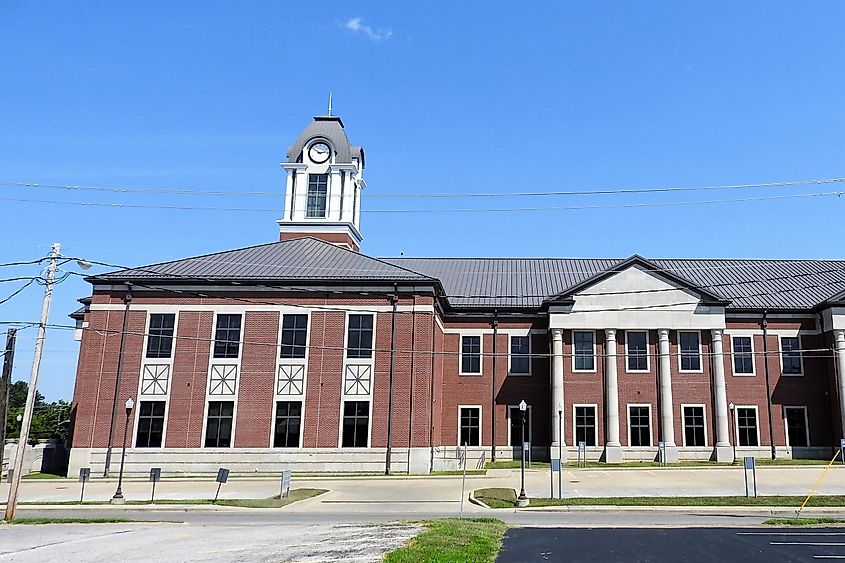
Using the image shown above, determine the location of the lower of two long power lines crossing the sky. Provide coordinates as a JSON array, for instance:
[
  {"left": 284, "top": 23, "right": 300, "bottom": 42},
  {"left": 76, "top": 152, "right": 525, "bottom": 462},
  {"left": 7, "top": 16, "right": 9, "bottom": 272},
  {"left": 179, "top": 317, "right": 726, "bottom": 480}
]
[{"left": 0, "top": 191, "right": 845, "bottom": 214}]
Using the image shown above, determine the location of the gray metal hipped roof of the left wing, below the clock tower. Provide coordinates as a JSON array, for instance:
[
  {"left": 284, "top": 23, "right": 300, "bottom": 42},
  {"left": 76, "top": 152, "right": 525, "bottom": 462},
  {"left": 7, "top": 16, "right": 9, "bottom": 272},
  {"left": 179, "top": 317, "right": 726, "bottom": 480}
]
[{"left": 93, "top": 237, "right": 434, "bottom": 282}]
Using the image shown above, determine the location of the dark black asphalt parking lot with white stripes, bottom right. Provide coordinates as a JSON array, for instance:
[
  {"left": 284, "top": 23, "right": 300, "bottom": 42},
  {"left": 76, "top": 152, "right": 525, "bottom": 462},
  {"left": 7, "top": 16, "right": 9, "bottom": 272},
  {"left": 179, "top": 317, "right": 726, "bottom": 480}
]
[{"left": 497, "top": 528, "right": 845, "bottom": 563}]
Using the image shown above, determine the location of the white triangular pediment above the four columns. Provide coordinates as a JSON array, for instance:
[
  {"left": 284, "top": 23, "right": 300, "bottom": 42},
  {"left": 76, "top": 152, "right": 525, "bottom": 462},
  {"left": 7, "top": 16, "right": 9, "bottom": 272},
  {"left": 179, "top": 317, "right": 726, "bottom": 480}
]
[{"left": 549, "top": 264, "right": 725, "bottom": 329}]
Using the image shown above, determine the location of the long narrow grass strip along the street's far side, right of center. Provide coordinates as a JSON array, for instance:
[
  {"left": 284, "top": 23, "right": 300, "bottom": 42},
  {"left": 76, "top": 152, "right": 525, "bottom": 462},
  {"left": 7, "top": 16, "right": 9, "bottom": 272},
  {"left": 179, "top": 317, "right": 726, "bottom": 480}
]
[{"left": 474, "top": 488, "right": 845, "bottom": 508}]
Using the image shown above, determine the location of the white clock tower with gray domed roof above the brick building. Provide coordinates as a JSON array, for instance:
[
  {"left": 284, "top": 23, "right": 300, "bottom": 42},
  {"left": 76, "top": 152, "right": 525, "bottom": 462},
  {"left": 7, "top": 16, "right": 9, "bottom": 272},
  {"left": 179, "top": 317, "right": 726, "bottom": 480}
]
[{"left": 278, "top": 109, "right": 366, "bottom": 251}]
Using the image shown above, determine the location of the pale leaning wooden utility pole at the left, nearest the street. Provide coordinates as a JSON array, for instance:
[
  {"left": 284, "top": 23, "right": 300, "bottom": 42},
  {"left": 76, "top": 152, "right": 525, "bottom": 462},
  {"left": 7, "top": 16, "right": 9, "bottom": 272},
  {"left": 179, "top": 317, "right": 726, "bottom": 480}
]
[{"left": 5, "top": 242, "right": 61, "bottom": 522}]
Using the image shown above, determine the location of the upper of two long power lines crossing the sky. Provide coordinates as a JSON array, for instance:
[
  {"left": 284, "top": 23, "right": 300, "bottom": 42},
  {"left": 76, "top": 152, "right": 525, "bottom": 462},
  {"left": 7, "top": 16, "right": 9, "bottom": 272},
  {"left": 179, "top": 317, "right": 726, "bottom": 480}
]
[{"left": 0, "top": 178, "right": 845, "bottom": 199}]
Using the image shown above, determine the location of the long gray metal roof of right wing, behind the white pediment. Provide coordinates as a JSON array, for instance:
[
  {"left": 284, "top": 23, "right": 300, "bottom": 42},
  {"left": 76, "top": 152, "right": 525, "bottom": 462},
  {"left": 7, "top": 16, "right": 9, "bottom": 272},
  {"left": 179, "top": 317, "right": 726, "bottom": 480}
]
[{"left": 385, "top": 258, "right": 845, "bottom": 310}]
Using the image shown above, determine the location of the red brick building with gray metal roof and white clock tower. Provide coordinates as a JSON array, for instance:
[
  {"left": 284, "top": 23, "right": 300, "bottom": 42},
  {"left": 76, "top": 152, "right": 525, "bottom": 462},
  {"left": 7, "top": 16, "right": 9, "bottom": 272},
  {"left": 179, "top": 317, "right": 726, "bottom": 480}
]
[{"left": 70, "top": 112, "right": 845, "bottom": 473}]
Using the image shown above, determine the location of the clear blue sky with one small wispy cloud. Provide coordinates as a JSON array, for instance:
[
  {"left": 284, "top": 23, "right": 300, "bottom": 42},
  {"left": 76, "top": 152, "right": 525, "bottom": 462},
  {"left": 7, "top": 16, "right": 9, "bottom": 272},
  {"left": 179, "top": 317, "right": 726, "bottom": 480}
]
[{"left": 0, "top": 4, "right": 845, "bottom": 399}]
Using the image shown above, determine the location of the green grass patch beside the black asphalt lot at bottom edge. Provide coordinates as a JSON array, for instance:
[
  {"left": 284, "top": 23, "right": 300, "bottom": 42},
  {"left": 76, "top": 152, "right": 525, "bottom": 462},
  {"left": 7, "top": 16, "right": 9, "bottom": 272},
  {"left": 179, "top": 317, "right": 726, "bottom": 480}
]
[{"left": 384, "top": 518, "right": 507, "bottom": 563}]
